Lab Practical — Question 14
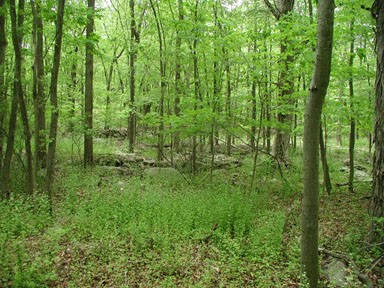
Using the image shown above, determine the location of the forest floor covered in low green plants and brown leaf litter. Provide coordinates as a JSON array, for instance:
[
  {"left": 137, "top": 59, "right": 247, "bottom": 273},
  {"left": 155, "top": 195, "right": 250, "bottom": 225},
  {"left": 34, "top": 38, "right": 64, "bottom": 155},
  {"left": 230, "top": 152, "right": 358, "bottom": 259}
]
[{"left": 0, "top": 140, "right": 384, "bottom": 287}]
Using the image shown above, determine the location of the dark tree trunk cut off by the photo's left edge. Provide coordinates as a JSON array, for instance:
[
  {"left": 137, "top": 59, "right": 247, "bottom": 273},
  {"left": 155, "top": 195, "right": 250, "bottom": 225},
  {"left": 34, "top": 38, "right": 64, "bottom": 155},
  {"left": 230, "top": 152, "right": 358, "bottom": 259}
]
[{"left": 0, "top": 0, "right": 8, "bottom": 175}]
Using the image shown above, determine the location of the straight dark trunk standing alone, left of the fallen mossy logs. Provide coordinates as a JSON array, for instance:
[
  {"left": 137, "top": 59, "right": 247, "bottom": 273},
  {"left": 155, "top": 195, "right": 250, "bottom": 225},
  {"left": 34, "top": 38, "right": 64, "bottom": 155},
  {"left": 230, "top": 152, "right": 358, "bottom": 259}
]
[{"left": 84, "top": 0, "right": 95, "bottom": 166}]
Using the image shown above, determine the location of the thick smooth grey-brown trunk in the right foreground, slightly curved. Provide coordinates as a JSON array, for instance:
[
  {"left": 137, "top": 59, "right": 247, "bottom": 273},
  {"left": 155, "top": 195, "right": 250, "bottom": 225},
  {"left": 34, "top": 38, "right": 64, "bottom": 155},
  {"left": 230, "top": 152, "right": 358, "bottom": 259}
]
[{"left": 301, "top": 0, "right": 335, "bottom": 288}]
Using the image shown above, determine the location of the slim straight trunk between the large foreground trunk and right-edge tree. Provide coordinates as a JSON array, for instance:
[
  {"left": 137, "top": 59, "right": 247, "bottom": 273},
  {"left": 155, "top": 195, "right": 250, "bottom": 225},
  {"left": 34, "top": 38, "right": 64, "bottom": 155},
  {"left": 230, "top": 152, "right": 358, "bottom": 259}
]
[{"left": 348, "top": 20, "right": 356, "bottom": 192}]
